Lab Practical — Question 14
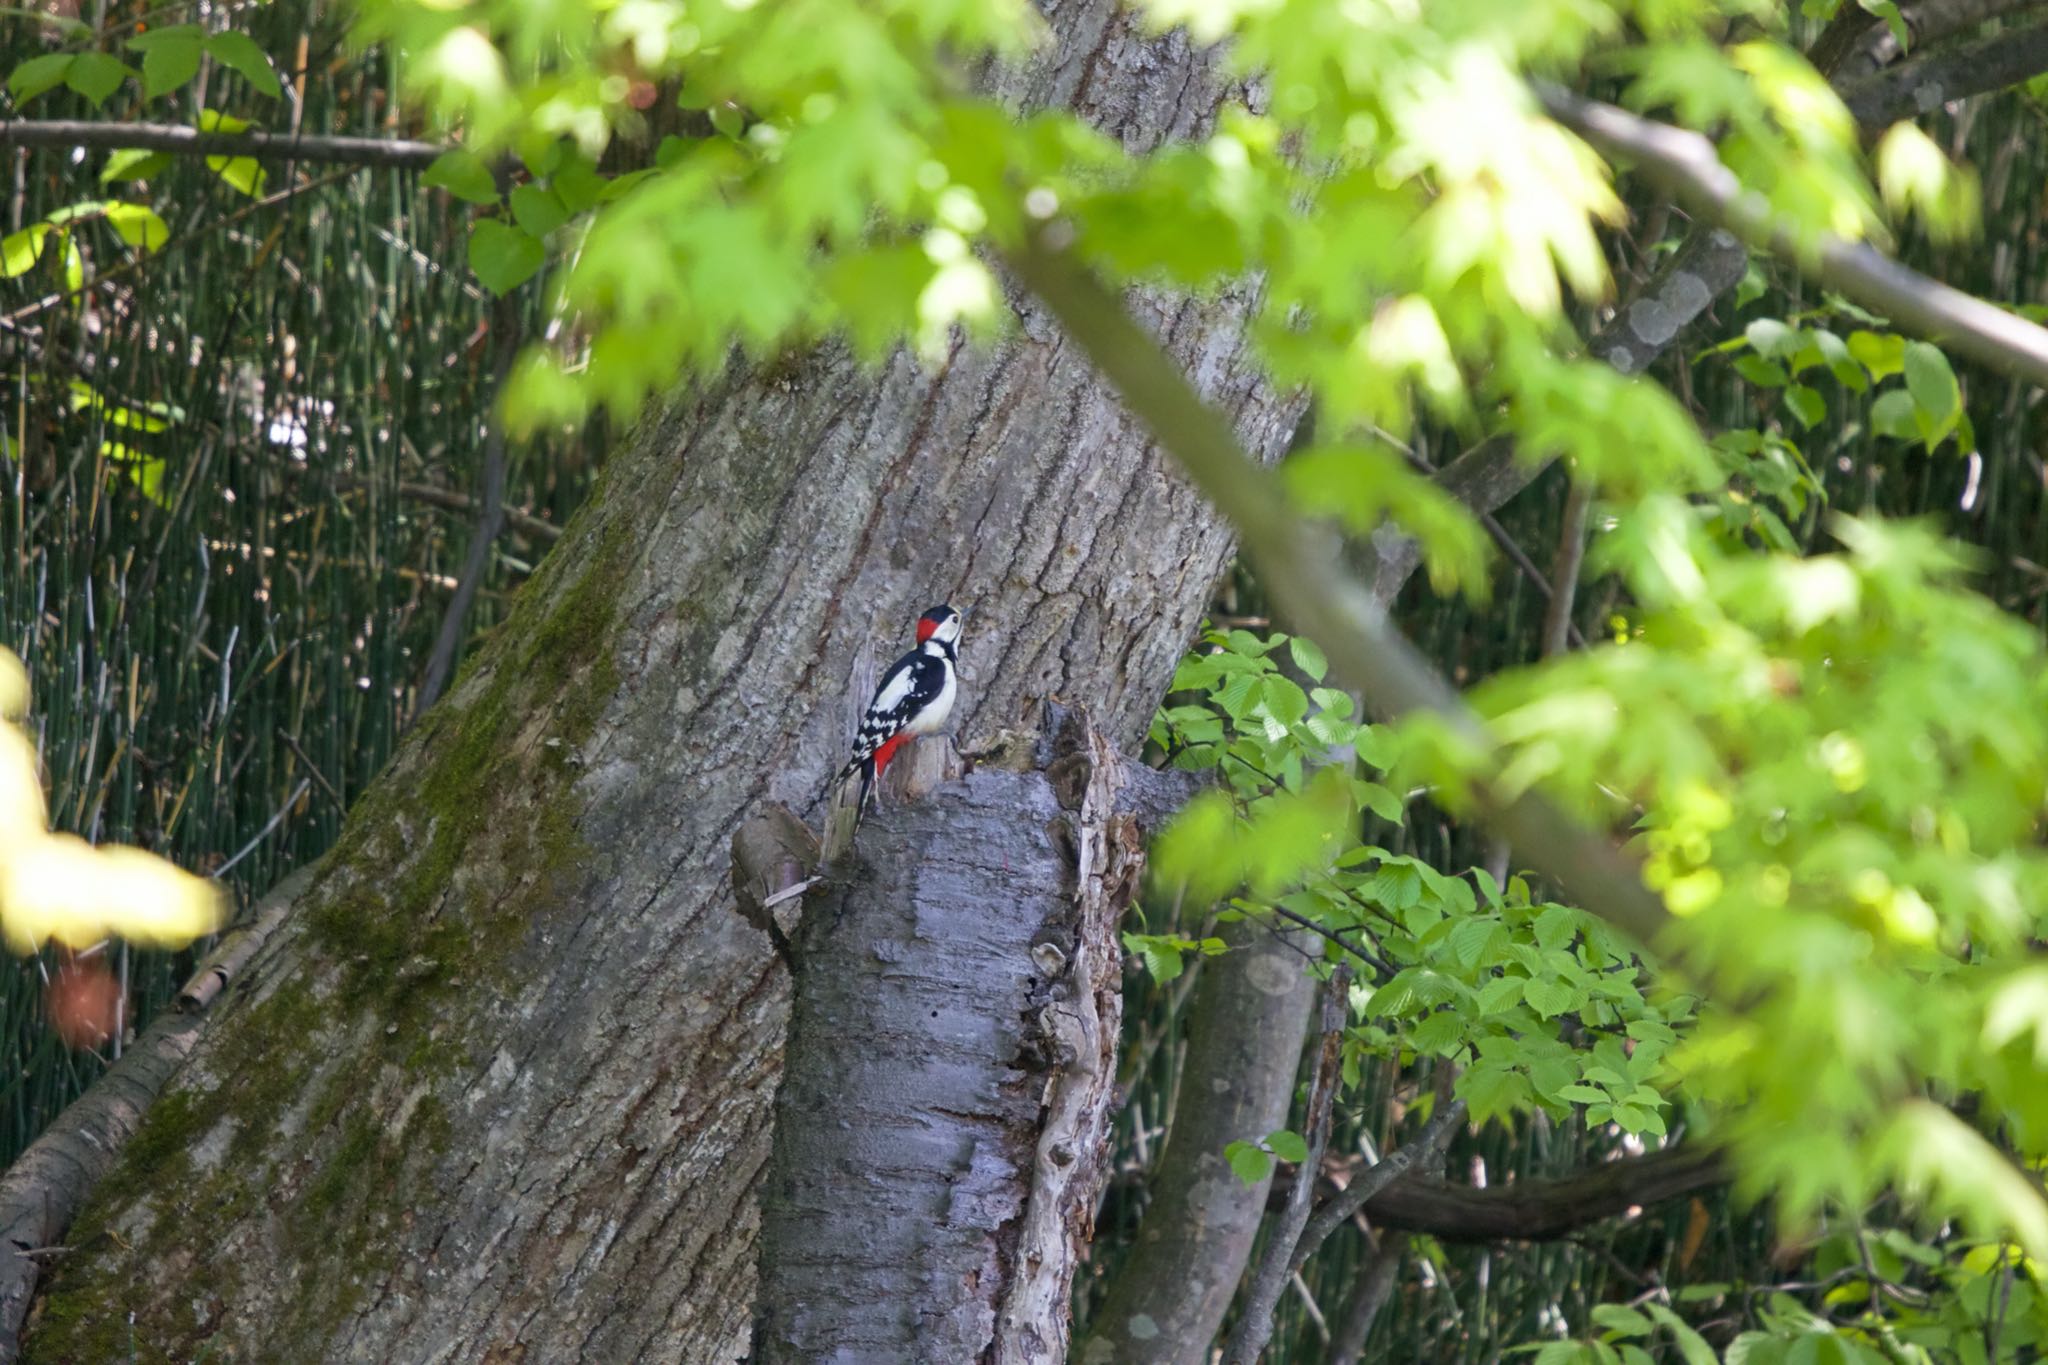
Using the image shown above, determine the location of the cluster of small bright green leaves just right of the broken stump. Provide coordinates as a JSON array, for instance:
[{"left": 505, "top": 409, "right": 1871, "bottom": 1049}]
[{"left": 1126, "top": 630, "right": 1692, "bottom": 1146}]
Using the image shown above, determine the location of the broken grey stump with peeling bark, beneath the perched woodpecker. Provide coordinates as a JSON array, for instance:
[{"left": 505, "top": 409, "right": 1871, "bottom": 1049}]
[{"left": 754, "top": 716, "right": 1143, "bottom": 1365}]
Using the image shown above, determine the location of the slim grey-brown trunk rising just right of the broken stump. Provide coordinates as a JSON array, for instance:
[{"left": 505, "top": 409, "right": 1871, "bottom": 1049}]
[{"left": 1073, "top": 923, "right": 1315, "bottom": 1365}]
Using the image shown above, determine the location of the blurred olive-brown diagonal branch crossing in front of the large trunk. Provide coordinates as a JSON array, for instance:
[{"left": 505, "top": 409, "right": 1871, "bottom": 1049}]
[{"left": 1010, "top": 241, "right": 1669, "bottom": 943}]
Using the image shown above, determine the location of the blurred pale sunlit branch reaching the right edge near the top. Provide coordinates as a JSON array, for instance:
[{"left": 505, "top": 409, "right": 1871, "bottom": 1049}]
[{"left": 1538, "top": 86, "right": 2048, "bottom": 387}]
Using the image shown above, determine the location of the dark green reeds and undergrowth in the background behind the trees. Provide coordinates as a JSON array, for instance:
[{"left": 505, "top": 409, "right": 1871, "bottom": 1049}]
[{"left": 0, "top": 0, "right": 2048, "bottom": 1365}]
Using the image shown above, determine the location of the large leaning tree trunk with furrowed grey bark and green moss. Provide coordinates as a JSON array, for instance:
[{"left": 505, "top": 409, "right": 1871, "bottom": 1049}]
[{"left": 16, "top": 13, "right": 1298, "bottom": 1365}]
